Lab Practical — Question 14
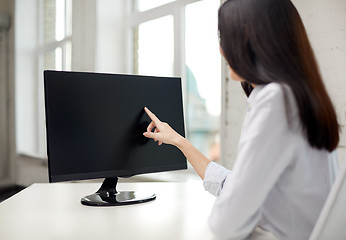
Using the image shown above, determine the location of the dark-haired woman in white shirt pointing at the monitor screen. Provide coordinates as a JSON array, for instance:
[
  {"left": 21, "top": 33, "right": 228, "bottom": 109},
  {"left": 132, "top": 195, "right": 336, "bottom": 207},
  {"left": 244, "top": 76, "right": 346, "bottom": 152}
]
[{"left": 144, "top": 0, "right": 339, "bottom": 239}]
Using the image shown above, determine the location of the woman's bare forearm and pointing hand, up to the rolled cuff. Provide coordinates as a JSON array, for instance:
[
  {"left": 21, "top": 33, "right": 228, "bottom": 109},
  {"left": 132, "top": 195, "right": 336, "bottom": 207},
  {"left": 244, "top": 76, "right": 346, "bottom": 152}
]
[{"left": 143, "top": 107, "right": 211, "bottom": 179}]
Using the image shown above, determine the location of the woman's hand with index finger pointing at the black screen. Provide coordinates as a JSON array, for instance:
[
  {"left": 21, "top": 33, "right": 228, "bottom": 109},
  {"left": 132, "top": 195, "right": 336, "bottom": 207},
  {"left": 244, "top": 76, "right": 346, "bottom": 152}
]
[{"left": 143, "top": 107, "right": 184, "bottom": 146}]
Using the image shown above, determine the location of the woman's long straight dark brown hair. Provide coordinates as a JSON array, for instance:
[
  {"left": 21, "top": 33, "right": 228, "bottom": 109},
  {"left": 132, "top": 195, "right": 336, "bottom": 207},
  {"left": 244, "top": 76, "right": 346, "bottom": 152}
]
[{"left": 219, "top": 0, "right": 339, "bottom": 151}]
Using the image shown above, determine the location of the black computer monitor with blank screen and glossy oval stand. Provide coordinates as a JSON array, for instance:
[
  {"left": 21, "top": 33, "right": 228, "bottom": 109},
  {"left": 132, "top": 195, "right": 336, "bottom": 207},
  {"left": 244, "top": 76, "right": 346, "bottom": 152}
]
[{"left": 44, "top": 71, "right": 187, "bottom": 206}]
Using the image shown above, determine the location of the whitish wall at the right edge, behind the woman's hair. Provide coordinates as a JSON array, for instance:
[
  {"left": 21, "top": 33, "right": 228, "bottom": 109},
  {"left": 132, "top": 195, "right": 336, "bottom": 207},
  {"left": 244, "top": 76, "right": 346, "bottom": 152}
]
[{"left": 294, "top": 0, "right": 346, "bottom": 161}]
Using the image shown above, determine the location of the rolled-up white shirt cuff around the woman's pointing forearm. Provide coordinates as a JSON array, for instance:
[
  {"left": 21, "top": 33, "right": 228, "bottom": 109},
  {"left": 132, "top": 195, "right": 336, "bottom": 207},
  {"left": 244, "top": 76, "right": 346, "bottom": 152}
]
[{"left": 203, "top": 162, "right": 231, "bottom": 196}]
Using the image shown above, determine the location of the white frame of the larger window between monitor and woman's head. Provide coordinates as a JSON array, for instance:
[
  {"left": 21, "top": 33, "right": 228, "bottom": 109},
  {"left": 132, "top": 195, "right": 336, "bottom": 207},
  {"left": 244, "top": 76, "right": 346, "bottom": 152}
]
[{"left": 125, "top": 0, "right": 227, "bottom": 163}]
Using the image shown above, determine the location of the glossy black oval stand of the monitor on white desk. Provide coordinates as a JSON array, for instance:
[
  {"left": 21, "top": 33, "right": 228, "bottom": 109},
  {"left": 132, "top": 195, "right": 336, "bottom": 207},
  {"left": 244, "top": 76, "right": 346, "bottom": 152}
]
[{"left": 81, "top": 177, "right": 156, "bottom": 206}]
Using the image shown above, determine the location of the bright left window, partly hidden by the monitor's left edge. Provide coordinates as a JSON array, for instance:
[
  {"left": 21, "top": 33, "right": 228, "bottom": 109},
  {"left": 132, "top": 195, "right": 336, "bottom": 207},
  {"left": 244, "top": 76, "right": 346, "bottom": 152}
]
[{"left": 16, "top": 0, "right": 72, "bottom": 158}]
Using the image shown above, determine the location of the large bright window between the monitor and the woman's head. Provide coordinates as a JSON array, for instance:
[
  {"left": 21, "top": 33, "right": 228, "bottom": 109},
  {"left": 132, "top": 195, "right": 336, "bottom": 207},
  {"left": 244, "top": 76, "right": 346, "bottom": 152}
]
[{"left": 127, "top": 0, "right": 221, "bottom": 169}]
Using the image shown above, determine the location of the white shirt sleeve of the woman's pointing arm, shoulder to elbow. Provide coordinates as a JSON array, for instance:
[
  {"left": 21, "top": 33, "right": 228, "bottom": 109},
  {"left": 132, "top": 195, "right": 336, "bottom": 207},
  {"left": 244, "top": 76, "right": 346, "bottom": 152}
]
[{"left": 205, "top": 84, "right": 295, "bottom": 239}]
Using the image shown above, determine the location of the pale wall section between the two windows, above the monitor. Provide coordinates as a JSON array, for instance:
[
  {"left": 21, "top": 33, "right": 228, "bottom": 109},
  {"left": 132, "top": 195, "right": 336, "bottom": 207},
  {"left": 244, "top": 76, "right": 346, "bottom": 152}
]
[{"left": 72, "top": 0, "right": 125, "bottom": 73}]
